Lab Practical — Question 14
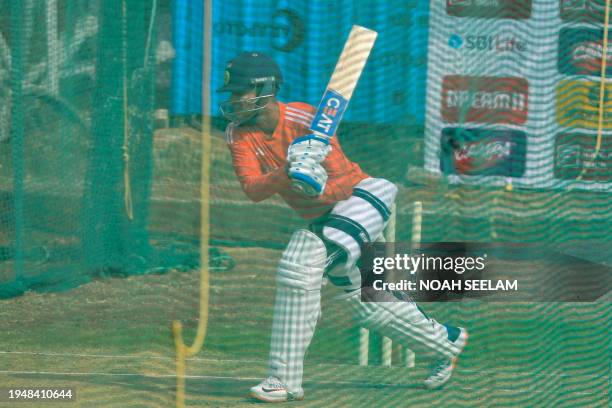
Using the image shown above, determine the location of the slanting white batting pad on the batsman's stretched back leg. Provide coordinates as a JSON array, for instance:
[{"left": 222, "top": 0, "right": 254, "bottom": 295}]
[{"left": 339, "top": 288, "right": 461, "bottom": 358}]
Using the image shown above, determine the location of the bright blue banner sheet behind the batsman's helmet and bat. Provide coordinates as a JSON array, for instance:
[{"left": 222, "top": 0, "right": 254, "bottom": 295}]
[{"left": 172, "top": 0, "right": 429, "bottom": 126}]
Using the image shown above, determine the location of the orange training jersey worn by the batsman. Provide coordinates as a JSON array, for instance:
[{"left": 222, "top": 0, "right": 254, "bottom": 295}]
[{"left": 225, "top": 102, "right": 369, "bottom": 218}]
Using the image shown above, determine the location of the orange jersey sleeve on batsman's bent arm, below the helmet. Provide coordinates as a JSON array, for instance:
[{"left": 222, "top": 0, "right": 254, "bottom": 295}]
[{"left": 228, "top": 126, "right": 291, "bottom": 202}]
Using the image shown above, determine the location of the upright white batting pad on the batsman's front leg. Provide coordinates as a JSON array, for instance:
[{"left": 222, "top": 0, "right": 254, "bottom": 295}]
[{"left": 269, "top": 229, "right": 327, "bottom": 392}]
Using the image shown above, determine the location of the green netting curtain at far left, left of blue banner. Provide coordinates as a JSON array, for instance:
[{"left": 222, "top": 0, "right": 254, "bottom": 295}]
[{"left": 3, "top": 2, "right": 155, "bottom": 294}]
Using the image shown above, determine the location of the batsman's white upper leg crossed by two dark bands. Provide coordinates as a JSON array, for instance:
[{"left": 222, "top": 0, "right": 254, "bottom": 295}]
[{"left": 323, "top": 178, "right": 397, "bottom": 289}]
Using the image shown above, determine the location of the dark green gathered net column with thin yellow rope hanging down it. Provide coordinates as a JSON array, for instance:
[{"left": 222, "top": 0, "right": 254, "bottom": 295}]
[{"left": 82, "top": 1, "right": 153, "bottom": 274}]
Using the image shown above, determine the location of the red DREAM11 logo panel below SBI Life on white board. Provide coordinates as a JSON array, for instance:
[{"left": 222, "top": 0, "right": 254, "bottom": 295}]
[{"left": 441, "top": 75, "right": 529, "bottom": 125}]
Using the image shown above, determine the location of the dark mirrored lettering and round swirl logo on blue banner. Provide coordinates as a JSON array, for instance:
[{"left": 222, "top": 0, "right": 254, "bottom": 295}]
[{"left": 213, "top": 9, "right": 306, "bottom": 52}]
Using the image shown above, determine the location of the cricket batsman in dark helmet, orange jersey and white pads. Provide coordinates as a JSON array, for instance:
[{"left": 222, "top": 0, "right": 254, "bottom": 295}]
[{"left": 219, "top": 52, "right": 468, "bottom": 402}]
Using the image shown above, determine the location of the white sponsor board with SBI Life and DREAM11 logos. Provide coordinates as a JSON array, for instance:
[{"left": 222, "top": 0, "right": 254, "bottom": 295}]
[{"left": 425, "top": 0, "right": 612, "bottom": 191}]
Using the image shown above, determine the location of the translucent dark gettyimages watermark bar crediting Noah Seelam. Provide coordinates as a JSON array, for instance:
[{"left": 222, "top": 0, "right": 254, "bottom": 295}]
[{"left": 359, "top": 242, "right": 612, "bottom": 302}]
